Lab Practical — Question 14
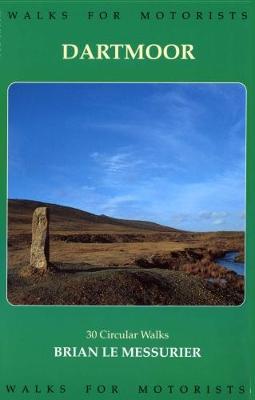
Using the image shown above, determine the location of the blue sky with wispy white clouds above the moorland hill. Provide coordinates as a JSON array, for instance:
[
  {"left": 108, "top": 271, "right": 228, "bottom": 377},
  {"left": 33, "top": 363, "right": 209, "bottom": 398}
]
[{"left": 9, "top": 84, "right": 245, "bottom": 231}]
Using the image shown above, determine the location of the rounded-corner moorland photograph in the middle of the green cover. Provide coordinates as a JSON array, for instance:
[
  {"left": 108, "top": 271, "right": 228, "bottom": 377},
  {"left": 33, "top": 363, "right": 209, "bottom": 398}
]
[{"left": 7, "top": 83, "right": 246, "bottom": 306}]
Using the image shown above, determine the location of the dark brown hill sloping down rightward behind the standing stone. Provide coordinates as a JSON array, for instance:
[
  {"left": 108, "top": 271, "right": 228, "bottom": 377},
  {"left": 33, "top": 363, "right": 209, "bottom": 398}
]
[{"left": 8, "top": 199, "right": 181, "bottom": 234}]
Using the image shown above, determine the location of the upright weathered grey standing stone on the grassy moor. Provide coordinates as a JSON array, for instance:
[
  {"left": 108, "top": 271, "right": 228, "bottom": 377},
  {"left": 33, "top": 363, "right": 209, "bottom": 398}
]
[{"left": 30, "top": 207, "right": 49, "bottom": 271}]
